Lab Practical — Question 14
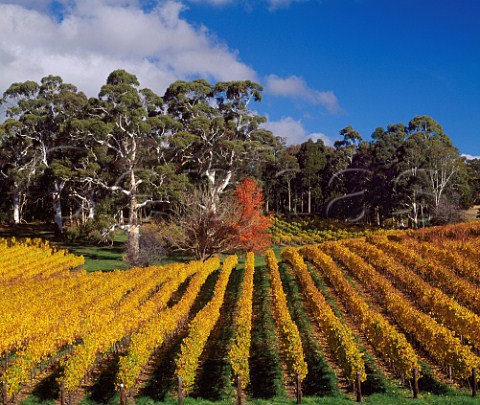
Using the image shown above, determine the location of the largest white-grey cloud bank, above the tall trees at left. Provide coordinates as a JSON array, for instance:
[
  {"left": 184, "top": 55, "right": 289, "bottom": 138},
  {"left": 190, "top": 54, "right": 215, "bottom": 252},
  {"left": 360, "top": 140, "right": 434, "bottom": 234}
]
[{"left": 0, "top": 0, "right": 257, "bottom": 96}]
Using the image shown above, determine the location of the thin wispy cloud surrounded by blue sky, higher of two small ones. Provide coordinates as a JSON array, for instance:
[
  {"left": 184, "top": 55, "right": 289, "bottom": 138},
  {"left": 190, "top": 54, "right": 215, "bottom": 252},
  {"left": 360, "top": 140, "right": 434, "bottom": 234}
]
[{"left": 265, "top": 75, "right": 342, "bottom": 114}]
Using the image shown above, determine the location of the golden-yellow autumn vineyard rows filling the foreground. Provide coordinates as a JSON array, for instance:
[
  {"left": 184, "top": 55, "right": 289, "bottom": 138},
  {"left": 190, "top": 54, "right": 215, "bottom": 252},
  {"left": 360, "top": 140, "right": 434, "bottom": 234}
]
[{"left": 0, "top": 221, "right": 480, "bottom": 403}]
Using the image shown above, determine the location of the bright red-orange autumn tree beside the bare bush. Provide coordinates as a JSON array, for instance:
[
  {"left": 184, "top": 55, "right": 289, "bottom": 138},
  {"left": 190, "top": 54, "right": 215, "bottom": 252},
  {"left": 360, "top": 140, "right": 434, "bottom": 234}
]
[{"left": 234, "top": 177, "right": 272, "bottom": 252}]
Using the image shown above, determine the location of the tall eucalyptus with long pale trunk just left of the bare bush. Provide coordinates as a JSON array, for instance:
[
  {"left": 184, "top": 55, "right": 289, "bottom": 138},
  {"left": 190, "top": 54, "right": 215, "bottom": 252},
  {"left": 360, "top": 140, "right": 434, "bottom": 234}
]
[{"left": 73, "top": 70, "right": 179, "bottom": 262}]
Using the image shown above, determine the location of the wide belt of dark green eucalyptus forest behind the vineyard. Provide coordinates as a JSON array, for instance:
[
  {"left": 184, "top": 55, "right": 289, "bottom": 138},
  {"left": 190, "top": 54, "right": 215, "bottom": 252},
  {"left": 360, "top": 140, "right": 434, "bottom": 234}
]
[{"left": 0, "top": 70, "right": 480, "bottom": 260}]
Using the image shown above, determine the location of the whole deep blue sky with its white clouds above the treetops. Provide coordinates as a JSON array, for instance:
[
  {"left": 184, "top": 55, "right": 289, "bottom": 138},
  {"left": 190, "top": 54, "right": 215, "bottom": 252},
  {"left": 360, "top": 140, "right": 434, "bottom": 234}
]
[{"left": 0, "top": 0, "right": 480, "bottom": 156}]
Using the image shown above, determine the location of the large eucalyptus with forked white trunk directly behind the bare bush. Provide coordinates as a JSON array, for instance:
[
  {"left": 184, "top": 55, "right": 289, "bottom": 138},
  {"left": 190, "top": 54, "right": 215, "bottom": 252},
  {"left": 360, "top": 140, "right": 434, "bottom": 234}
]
[{"left": 164, "top": 79, "right": 278, "bottom": 210}]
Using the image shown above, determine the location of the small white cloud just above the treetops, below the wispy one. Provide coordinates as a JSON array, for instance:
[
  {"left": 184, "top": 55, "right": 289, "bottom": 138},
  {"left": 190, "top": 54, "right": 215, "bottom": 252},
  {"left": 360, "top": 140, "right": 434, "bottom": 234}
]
[{"left": 263, "top": 117, "right": 333, "bottom": 146}]
